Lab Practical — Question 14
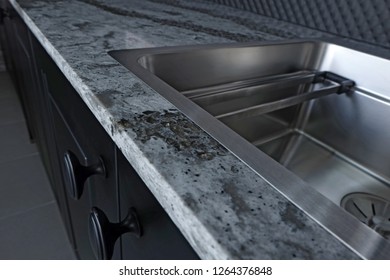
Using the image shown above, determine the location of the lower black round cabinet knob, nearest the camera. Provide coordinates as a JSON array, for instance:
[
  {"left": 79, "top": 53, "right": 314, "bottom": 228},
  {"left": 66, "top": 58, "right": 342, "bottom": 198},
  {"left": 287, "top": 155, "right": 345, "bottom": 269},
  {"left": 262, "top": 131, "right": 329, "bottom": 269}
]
[{"left": 89, "top": 207, "right": 142, "bottom": 260}]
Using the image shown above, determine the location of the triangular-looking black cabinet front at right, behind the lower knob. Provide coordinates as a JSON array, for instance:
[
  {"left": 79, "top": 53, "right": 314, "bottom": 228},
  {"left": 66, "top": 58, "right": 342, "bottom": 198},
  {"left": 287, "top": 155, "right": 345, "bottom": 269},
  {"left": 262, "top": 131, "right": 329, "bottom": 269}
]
[{"left": 117, "top": 150, "right": 198, "bottom": 259}]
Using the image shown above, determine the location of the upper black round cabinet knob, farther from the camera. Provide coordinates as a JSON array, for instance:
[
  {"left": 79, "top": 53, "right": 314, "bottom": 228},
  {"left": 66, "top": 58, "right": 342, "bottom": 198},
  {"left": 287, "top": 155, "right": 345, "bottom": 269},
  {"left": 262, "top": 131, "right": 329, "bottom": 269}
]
[{"left": 64, "top": 151, "right": 106, "bottom": 200}]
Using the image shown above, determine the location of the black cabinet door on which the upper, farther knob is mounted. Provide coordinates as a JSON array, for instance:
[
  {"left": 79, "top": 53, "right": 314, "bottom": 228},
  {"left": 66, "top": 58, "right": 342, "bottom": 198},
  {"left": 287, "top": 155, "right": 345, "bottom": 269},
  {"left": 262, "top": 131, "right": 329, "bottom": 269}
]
[{"left": 40, "top": 47, "right": 120, "bottom": 259}]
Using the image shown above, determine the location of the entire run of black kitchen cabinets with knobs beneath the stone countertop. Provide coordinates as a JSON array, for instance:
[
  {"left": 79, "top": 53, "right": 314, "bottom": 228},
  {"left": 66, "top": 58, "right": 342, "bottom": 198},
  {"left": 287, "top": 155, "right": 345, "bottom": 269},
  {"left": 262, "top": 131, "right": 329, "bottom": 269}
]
[{"left": 0, "top": 0, "right": 198, "bottom": 259}]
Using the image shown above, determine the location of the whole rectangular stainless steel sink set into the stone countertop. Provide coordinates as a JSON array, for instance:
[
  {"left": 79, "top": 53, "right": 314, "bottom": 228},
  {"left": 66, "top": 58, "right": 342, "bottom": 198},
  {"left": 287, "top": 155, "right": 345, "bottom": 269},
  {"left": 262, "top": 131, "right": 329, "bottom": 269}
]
[{"left": 109, "top": 41, "right": 390, "bottom": 259}]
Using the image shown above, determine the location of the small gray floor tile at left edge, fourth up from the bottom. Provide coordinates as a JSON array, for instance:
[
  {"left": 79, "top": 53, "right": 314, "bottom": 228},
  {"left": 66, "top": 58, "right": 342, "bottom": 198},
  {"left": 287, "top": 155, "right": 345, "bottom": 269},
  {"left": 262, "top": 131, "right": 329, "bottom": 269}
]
[{"left": 0, "top": 96, "right": 24, "bottom": 126}]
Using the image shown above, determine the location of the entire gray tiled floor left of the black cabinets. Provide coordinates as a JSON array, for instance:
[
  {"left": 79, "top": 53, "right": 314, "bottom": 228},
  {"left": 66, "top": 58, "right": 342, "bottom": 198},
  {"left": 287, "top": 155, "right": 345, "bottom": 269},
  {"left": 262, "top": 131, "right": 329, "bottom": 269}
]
[{"left": 0, "top": 71, "right": 75, "bottom": 260}]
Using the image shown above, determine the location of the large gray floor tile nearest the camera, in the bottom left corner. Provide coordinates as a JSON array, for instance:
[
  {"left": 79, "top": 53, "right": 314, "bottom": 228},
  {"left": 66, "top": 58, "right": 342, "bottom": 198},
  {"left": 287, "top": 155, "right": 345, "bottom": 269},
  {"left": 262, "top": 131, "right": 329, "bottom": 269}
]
[{"left": 0, "top": 203, "right": 75, "bottom": 260}]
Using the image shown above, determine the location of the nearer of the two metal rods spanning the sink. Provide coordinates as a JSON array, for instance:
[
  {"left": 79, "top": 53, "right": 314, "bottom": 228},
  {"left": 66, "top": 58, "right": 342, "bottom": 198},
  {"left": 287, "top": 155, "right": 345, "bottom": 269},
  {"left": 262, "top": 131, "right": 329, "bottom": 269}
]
[{"left": 215, "top": 82, "right": 340, "bottom": 121}]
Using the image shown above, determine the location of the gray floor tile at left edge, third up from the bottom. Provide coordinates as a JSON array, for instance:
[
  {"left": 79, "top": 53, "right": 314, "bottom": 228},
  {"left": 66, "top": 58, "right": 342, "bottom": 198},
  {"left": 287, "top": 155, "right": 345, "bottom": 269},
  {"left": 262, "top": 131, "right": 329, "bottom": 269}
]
[{"left": 0, "top": 122, "right": 37, "bottom": 163}]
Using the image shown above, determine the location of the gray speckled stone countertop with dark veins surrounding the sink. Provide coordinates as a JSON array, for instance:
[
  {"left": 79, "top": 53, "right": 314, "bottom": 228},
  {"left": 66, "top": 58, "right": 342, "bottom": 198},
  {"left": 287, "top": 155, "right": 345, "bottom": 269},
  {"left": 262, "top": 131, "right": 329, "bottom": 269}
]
[{"left": 6, "top": 0, "right": 366, "bottom": 259}]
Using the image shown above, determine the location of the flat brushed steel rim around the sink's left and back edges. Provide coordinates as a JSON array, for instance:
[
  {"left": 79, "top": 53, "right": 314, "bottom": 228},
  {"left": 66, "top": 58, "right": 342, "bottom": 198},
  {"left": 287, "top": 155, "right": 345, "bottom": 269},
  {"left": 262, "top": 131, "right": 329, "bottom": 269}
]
[{"left": 109, "top": 39, "right": 390, "bottom": 259}]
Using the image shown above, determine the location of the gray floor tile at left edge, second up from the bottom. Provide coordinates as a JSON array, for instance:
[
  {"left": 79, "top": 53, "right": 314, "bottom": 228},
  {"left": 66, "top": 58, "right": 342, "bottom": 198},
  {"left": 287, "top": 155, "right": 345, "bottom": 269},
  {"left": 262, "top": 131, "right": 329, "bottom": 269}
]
[{"left": 0, "top": 155, "right": 54, "bottom": 219}]
